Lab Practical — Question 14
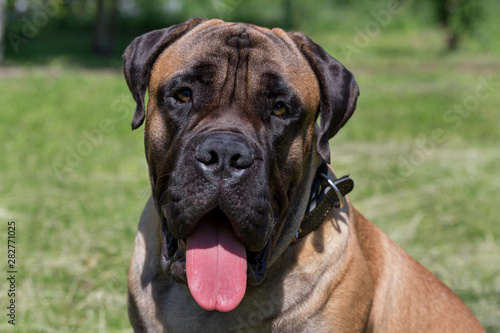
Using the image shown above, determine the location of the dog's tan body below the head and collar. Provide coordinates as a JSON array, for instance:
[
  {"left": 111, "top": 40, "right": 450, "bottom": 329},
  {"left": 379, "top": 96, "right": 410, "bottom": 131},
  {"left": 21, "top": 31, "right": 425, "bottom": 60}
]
[{"left": 129, "top": 169, "right": 484, "bottom": 333}]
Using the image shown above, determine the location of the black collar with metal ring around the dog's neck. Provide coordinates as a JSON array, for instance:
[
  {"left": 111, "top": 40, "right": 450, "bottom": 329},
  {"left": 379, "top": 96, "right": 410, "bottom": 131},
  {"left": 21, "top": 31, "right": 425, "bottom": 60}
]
[{"left": 295, "top": 161, "right": 354, "bottom": 240}]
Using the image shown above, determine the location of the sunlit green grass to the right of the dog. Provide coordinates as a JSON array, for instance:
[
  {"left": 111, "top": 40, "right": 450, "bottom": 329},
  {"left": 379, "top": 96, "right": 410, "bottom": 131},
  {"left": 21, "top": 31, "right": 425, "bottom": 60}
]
[{"left": 319, "top": 30, "right": 500, "bottom": 332}]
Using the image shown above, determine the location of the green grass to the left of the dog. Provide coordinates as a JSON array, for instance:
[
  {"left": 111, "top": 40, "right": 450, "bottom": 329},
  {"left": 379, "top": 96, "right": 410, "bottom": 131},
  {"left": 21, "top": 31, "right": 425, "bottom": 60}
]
[{"left": 0, "top": 68, "right": 148, "bottom": 332}]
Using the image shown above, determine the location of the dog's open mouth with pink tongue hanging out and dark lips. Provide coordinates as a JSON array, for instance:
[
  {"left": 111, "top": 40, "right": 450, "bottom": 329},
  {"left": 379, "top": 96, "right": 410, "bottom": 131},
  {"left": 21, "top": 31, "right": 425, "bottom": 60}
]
[{"left": 161, "top": 208, "right": 272, "bottom": 312}]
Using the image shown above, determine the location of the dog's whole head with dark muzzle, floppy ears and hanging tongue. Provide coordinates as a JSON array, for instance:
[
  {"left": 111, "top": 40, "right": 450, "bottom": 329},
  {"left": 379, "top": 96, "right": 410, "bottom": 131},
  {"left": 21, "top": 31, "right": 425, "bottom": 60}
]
[{"left": 124, "top": 20, "right": 358, "bottom": 311}]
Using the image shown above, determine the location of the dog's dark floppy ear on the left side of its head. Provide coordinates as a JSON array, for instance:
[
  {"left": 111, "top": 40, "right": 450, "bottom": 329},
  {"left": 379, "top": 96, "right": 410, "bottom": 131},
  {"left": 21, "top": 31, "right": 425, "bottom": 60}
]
[{"left": 122, "top": 19, "right": 206, "bottom": 130}]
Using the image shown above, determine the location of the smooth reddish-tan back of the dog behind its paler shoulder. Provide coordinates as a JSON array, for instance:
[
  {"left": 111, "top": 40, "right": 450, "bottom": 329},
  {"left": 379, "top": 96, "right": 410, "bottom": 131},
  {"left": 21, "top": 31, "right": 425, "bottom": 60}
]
[{"left": 353, "top": 211, "right": 483, "bottom": 332}]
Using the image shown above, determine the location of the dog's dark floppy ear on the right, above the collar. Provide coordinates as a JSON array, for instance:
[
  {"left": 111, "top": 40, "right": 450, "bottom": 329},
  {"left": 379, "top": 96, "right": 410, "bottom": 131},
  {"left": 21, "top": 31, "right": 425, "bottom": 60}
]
[{"left": 291, "top": 32, "right": 359, "bottom": 163}]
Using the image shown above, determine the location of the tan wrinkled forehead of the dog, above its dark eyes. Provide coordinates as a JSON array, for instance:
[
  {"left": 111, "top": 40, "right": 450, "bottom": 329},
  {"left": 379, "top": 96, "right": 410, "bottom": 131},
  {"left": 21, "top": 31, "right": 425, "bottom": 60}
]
[{"left": 149, "top": 20, "right": 319, "bottom": 105}]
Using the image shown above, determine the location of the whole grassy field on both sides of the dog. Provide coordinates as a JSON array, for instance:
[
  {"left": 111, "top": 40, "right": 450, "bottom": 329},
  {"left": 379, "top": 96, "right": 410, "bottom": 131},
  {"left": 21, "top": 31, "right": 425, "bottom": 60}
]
[{"left": 0, "top": 11, "right": 500, "bottom": 332}]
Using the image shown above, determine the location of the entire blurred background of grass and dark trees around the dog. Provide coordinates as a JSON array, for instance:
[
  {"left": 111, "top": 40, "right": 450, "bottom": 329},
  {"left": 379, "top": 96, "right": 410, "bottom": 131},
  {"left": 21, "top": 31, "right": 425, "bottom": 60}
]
[{"left": 0, "top": 0, "right": 500, "bottom": 332}]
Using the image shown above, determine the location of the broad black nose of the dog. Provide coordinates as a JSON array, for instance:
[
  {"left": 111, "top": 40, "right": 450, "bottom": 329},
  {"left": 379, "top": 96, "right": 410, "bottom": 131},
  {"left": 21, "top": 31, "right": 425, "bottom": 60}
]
[{"left": 195, "top": 133, "right": 254, "bottom": 179}]
